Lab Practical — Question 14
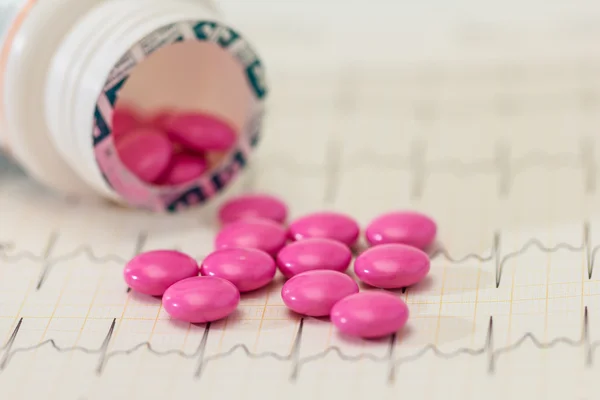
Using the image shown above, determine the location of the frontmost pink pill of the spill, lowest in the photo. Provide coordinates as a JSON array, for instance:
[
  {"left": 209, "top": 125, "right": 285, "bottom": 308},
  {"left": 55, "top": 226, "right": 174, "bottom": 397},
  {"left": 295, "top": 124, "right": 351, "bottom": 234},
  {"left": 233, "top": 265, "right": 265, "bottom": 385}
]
[{"left": 331, "top": 291, "right": 409, "bottom": 339}]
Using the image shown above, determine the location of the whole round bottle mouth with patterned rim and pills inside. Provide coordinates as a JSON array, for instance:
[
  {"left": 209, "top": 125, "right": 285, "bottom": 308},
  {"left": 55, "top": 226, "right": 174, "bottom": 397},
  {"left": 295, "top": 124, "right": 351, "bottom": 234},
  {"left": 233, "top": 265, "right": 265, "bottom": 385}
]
[{"left": 94, "top": 22, "right": 266, "bottom": 211}]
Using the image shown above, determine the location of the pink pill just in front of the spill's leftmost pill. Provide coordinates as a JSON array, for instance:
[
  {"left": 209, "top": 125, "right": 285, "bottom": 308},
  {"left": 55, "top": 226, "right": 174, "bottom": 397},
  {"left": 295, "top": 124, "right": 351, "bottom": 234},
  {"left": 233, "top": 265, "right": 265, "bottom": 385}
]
[{"left": 162, "top": 276, "right": 240, "bottom": 324}]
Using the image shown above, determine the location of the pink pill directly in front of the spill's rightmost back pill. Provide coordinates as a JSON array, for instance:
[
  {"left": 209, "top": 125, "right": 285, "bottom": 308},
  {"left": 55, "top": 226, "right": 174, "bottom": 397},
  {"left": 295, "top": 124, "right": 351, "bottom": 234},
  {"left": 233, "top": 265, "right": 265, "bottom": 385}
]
[{"left": 354, "top": 244, "right": 430, "bottom": 289}]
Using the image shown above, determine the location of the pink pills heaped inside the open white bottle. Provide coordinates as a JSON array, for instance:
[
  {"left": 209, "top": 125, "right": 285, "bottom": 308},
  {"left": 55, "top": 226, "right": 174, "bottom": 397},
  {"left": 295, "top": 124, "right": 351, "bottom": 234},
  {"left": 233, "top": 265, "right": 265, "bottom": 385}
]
[{"left": 112, "top": 106, "right": 237, "bottom": 185}]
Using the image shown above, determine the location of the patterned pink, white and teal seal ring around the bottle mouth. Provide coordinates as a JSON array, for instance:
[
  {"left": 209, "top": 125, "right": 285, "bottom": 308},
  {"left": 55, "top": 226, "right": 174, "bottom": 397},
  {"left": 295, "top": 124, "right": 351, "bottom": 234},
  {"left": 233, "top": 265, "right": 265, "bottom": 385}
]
[{"left": 93, "top": 21, "right": 267, "bottom": 212}]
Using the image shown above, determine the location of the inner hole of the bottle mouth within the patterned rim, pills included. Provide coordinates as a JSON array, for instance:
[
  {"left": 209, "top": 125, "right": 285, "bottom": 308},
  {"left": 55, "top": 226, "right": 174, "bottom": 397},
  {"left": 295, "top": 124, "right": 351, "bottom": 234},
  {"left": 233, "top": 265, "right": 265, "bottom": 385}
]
[{"left": 112, "top": 41, "right": 252, "bottom": 186}]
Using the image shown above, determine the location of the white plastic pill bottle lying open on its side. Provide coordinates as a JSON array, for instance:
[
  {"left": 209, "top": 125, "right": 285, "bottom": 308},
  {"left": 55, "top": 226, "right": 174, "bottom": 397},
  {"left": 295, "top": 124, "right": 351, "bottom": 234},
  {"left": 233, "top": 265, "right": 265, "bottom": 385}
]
[{"left": 0, "top": 0, "right": 267, "bottom": 212}]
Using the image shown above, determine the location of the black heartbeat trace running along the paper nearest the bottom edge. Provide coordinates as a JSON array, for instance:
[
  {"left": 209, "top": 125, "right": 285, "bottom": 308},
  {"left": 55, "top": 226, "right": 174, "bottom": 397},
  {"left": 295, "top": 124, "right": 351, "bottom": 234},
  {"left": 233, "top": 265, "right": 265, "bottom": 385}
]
[{"left": 0, "top": 306, "right": 600, "bottom": 385}]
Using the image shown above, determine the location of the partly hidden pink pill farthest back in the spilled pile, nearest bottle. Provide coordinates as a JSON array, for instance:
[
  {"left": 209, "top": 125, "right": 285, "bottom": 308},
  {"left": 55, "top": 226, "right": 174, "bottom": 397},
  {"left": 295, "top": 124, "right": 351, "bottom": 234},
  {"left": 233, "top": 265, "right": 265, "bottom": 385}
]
[{"left": 219, "top": 194, "right": 288, "bottom": 224}]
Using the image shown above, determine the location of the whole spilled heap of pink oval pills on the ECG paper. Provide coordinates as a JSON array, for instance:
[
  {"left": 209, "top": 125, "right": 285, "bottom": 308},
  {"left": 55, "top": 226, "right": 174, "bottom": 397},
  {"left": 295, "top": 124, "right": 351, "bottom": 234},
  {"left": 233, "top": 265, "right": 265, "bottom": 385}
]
[{"left": 124, "top": 195, "right": 437, "bottom": 338}]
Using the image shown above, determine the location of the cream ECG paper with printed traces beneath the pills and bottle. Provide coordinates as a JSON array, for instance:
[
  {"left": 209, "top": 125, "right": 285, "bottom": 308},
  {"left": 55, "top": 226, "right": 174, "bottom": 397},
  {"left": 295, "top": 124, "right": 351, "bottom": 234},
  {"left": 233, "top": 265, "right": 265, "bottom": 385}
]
[{"left": 0, "top": 1, "right": 600, "bottom": 400}]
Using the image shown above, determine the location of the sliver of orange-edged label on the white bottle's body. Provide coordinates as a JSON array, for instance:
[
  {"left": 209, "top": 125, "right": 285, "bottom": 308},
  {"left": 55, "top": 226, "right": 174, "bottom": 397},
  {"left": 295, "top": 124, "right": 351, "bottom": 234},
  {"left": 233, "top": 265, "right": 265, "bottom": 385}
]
[{"left": 0, "top": 0, "right": 37, "bottom": 154}]
